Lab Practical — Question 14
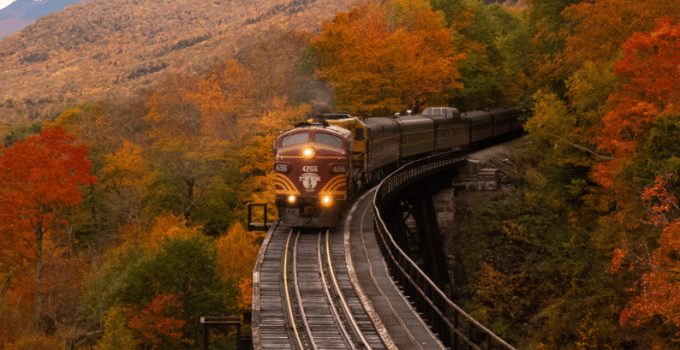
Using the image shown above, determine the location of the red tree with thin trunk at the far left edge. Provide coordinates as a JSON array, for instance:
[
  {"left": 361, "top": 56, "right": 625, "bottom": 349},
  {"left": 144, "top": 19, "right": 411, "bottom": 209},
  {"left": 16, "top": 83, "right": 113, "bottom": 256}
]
[{"left": 0, "top": 127, "right": 96, "bottom": 330}]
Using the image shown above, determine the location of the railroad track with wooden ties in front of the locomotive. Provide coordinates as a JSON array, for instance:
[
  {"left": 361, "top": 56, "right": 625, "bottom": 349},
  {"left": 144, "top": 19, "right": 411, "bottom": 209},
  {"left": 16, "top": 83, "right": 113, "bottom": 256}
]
[{"left": 258, "top": 223, "right": 385, "bottom": 349}]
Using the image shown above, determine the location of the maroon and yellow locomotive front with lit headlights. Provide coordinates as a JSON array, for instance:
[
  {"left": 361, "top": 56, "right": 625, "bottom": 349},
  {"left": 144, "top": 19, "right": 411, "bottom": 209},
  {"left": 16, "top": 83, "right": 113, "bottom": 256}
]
[{"left": 275, "top": 124, "right": 352, "bottom": 227}]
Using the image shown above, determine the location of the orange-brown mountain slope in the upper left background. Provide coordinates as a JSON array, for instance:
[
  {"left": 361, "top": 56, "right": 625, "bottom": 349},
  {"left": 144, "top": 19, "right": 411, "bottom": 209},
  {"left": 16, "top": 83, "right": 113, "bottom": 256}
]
[{"left": 0, "top": 0, "right": 356, "bottom": 120}]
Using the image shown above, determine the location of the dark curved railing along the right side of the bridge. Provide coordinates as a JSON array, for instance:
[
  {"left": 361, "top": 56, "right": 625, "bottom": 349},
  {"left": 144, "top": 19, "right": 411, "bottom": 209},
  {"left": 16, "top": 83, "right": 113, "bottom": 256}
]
[{"left": 373, "top": 151, "right": 514, "bottom": 350}]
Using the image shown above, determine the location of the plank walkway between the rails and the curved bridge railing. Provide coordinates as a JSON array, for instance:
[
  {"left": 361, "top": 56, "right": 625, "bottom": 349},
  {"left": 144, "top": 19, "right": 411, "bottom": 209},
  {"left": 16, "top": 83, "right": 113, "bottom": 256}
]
[{"left": 343, "top": 190, "right": 444, "bottom": 349}]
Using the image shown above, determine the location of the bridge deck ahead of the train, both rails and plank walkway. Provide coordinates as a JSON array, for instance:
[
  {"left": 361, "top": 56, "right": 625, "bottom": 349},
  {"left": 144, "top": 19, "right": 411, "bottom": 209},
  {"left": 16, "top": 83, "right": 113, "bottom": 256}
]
[{"left": 253, "top": 191, "right": 443, "bottom": 349}]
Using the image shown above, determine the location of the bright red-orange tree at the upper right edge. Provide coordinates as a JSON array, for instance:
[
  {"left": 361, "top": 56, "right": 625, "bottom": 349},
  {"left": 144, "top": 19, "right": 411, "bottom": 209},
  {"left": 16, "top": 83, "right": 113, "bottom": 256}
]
[{"left": 594, "top": 18, "right": 680, "bottom": 188}]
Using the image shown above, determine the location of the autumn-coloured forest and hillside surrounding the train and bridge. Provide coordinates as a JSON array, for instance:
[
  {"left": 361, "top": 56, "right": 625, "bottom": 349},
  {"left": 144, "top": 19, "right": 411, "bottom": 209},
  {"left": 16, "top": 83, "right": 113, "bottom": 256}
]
[{"left": 0, "top": 0, "right": 680, "bottom": 349}]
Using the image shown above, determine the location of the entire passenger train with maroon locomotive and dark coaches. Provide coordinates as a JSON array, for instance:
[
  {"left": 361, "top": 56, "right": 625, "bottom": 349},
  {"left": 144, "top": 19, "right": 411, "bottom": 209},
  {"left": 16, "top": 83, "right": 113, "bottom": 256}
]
[{"left": 274, "top": 107, "right": 522, "bottom": 228}]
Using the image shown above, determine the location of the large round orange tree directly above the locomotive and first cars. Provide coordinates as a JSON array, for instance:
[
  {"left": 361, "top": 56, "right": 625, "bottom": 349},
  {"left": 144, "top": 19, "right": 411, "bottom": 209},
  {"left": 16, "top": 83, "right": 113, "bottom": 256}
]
[{"left": 311, "top": 1, "right": 463, "bottom": 114}]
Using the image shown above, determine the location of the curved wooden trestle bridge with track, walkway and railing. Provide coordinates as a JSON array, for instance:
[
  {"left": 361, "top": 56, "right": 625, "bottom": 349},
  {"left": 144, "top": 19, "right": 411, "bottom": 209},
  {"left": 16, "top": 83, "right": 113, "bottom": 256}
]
[{"left": 252, "top": 152, "right": 514, "bottom": 350}]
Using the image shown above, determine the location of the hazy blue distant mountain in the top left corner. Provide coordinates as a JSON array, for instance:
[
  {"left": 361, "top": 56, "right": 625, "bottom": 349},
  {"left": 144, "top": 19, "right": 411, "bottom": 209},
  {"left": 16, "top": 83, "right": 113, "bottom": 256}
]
[{"left": 0, "top": 0, "right": 80, "bottom": 39}]
